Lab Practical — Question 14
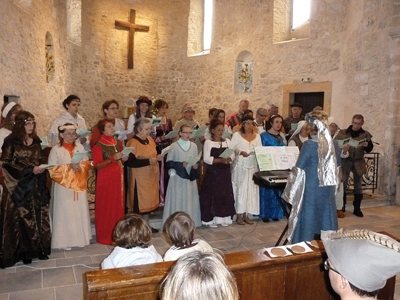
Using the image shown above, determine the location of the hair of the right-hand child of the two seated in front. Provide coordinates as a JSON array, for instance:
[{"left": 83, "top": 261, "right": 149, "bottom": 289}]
[{"left": 163, "top": 211, "right": 196, "bottom": 248}]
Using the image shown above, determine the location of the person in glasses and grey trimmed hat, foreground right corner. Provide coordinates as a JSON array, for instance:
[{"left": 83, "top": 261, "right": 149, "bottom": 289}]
[{"left": 321, "top": 229, "right": 400, "bottom": 300}]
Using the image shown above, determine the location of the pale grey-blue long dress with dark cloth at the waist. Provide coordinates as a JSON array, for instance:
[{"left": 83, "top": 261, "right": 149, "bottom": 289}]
[{"left": 162, "top": 142, "right": 201, "bottom": 226}]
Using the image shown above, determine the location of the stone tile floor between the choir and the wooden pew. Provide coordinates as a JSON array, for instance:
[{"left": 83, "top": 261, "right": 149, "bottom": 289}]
[{"left": 0, "top": 206, "right": 400, "bottom": 300}]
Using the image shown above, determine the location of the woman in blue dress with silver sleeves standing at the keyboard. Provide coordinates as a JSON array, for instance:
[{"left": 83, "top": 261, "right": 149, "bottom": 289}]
[{"left": 283, "top": 108, "right": 340, "bottom": 244}]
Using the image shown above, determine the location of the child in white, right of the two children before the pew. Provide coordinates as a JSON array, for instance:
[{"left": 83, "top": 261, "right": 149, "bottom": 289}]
[{"left": 164, "top": 211, "right": 213, "bottom": 261}]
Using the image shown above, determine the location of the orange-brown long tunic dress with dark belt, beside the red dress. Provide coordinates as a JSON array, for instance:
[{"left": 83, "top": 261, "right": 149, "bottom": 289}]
[{"left": 125, "top": 136, "right": 159, "bottom": 213}]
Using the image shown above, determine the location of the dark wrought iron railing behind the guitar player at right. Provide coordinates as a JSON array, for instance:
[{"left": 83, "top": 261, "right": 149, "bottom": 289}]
[{"left": 347, "top": 152, "right": 379, "bottom": 193}]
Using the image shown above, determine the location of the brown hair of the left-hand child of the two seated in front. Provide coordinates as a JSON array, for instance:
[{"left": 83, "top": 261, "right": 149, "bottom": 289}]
[{"left": 113, "top": 214, "right": 151, "bottom": 249}]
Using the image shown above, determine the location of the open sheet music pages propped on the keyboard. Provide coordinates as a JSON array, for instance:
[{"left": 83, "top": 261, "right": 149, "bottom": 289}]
[{"left": 255, "top": 146, "right": 299, "bottom": 171}]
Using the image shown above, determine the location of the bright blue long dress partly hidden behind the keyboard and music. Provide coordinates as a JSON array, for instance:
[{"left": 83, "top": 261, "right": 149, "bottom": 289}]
[{"left": 260, "top": 131, "right": 285, "bottom": 219}]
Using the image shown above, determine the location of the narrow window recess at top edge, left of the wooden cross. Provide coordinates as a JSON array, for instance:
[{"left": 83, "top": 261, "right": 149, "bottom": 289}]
[{"left": 67, "top": 0, "right": 82, "bottom": 46}]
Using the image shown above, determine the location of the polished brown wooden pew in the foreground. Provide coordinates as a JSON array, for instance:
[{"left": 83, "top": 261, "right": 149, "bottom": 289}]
[{"left": 83, "top": 249, "right": 395, "bottom": 300}]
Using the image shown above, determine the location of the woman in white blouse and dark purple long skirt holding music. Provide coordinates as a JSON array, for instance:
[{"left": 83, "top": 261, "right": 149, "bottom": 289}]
[{"left": 200, "top": 119, "right": 236, "bottom": 228}]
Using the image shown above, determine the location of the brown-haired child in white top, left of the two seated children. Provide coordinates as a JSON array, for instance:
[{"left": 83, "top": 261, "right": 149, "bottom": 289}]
[{"left": 101, "top": 214, "right": 162, "bottom": 269}]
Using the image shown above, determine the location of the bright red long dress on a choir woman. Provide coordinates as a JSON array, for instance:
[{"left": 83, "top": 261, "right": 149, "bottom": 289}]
[{"left": 93, "top": 134, "right": 125, "bottom": 245}]
